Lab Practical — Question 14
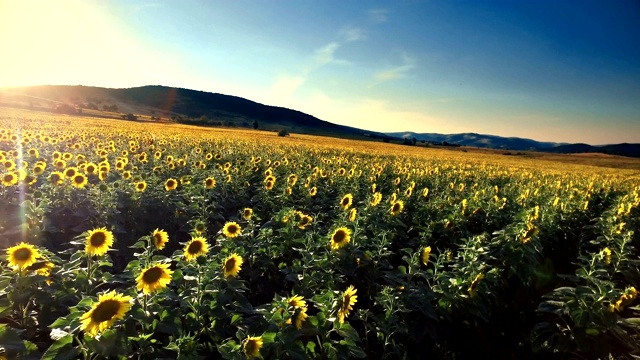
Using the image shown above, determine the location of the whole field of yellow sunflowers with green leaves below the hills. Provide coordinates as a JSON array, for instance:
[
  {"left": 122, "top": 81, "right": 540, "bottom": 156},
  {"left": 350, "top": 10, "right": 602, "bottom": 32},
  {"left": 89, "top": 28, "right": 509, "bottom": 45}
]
[{"left": 0, "top": 109, "right": 640, "bottom": 359}]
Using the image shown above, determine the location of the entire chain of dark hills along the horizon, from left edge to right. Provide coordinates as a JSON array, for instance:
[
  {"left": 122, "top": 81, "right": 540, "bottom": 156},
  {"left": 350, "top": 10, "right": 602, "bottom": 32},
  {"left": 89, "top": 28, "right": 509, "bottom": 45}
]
[{"left": 0, "top": 85, "right": 640, "bottom": 157}]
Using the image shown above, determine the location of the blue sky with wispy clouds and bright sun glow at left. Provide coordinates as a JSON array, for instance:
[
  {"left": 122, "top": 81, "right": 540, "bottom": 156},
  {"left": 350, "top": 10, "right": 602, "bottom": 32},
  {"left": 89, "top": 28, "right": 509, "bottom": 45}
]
[{"left": 0, "top": 0, "right": 640, "bottom": 144}]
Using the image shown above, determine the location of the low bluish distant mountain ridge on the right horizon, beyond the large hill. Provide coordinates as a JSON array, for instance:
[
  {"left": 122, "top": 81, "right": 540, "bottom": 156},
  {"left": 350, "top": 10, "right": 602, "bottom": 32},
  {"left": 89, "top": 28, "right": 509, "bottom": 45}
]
[{"left": 386, "top": 131, "right": 640, "bottom": 157}]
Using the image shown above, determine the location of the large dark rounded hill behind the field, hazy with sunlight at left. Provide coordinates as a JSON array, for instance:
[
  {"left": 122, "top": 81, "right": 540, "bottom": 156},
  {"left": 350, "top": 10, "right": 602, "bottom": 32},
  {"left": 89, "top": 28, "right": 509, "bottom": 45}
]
[{"left": 0, "top": 85, "right": 386, "bottom": 138}]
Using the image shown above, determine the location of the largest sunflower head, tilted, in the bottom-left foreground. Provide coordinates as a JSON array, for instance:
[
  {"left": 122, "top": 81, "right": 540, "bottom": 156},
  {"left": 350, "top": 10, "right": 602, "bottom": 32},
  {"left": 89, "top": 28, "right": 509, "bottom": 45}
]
[{"left": 80, "top": 291, "right": 132, "bottom": 337}]
